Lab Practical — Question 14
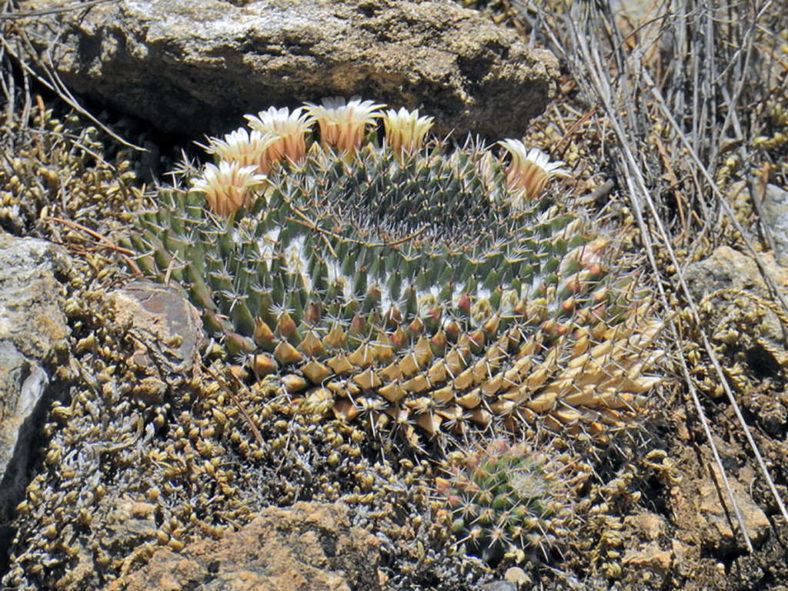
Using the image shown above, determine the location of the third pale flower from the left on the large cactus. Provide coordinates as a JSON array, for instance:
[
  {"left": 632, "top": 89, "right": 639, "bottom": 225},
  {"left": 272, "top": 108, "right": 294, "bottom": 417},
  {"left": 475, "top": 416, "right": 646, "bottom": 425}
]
[{"left": 244, "top": 107, "right": 313, "bottom": 162}]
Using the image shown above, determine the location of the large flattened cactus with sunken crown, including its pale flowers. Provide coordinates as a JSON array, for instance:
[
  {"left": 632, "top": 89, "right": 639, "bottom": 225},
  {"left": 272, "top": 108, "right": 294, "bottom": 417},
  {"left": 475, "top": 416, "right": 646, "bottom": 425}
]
[{"left": 124, "top": 100, "right": 660, "bottom": 441}]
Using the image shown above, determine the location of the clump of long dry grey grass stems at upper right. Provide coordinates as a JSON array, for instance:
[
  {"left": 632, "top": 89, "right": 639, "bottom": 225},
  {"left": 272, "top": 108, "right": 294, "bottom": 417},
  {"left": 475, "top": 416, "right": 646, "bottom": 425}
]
[{"left": 512, "top": 0, "right": 788, "bottom": 551}]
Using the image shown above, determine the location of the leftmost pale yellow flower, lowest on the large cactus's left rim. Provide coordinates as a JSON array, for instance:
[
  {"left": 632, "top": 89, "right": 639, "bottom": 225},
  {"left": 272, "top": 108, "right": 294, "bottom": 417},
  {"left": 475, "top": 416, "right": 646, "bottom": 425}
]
[{"left": 191, "top": 161, "right": 266, "bottom": 217}]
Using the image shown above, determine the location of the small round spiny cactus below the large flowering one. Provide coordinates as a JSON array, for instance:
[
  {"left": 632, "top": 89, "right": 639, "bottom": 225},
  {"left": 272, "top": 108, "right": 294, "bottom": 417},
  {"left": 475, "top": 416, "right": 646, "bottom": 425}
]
[{"left": 436, "top": 440, "right": 584, "bottom": 564}]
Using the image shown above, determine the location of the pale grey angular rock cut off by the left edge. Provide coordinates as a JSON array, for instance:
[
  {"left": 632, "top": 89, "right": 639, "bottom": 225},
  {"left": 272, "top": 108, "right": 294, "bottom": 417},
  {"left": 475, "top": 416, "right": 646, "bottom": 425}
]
[{"left": 0, "top": 230, "right": 69, "bottom": 560}]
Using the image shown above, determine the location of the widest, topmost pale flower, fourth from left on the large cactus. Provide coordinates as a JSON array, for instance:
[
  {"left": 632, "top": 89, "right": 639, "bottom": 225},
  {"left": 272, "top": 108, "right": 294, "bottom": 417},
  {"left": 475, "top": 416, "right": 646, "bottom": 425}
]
[{"left": 306, "top": 97, "right": 385, "bottom": 152}]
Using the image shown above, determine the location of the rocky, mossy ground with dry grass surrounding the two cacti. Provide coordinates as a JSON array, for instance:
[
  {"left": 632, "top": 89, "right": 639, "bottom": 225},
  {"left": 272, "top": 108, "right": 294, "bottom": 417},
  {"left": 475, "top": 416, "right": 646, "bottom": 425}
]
[{"left": 0, "top": 1, "right": 788, "bottom": 591}]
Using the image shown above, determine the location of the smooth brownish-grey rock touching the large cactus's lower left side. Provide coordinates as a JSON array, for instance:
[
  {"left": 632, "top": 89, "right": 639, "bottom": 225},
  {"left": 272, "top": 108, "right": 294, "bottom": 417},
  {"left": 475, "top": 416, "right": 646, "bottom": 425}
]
[{"left": 110, "top": 281, "right": 204, "bottom": 403}]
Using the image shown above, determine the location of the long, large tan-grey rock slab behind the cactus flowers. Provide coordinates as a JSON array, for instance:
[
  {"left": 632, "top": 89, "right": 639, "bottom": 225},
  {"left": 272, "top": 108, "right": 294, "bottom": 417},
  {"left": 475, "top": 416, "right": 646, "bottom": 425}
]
[{"left": 10, "top": 0, "right": 558, "bottom": 139}]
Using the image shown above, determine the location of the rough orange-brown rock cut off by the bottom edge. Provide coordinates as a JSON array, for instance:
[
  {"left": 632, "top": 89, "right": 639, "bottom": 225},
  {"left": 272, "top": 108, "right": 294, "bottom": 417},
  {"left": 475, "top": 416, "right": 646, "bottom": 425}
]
[{"left": 108, "top": 503, "right": 380, "bottom": 591}]
